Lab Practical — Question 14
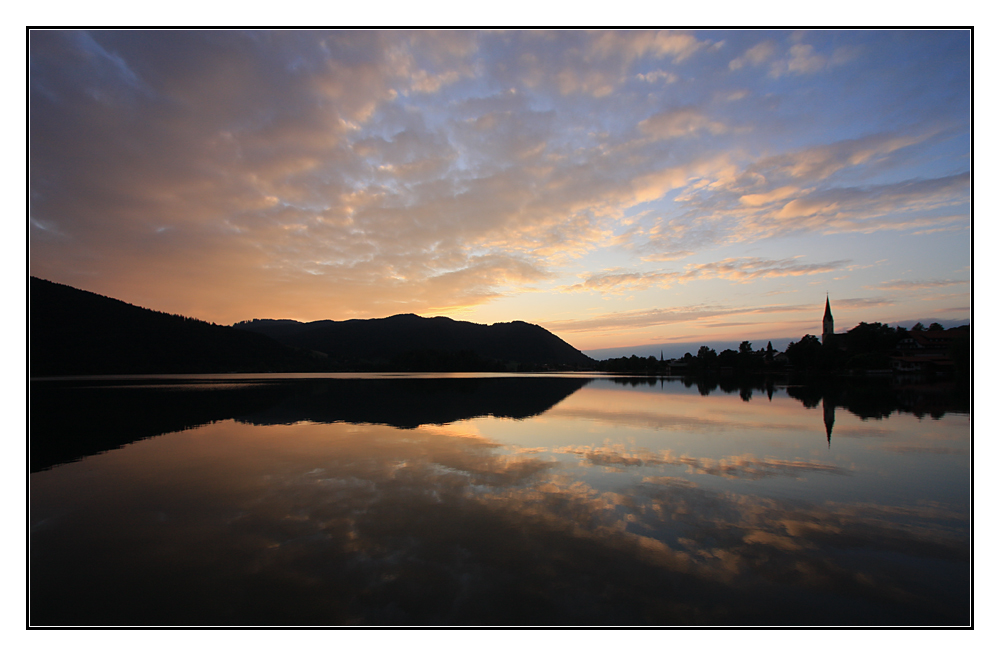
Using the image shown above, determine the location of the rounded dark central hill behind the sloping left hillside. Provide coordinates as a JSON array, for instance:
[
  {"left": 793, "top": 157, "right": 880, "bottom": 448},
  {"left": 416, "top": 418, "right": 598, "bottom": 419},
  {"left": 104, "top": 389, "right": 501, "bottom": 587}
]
[{"left": 235, "top": 314, "right": 595, "bottom": 371}]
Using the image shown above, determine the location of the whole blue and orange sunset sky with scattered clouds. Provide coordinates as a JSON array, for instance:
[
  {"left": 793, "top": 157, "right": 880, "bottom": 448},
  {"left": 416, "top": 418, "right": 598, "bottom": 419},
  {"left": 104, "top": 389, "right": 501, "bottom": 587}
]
[{"left": 28, "top": 30, "right": 972, "bottom": 351}]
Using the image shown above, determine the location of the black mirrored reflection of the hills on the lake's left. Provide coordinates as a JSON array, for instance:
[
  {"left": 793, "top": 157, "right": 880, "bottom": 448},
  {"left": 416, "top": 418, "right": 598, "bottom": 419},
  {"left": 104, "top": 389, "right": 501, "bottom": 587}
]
[{"left": 30, "top": 376, "right": 589, "bottom": 472}]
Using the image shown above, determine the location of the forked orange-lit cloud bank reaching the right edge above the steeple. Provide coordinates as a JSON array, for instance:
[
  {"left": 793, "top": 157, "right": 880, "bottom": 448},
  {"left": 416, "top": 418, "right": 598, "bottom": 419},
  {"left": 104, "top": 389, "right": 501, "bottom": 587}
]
[{"left": 624, "top": 130, "right": 970, "bottom": 261}]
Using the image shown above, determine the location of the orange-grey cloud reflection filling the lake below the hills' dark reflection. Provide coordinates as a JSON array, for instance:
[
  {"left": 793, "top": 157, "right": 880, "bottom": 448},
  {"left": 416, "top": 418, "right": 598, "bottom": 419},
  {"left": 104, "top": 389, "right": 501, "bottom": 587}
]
[{"left": 31, "top": 410, "right": 968, "bottom": 625}]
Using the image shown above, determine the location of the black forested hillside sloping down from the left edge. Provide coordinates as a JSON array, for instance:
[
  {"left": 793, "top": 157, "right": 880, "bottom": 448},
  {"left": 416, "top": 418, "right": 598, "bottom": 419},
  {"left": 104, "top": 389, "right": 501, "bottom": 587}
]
[{"left": 28, "top": 277, "right": 317, "bottom": 377}]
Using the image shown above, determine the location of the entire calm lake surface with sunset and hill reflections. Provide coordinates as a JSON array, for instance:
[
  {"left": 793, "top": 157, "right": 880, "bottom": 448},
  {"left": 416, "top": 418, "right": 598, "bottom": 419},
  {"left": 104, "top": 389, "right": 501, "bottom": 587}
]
[{"left": 29, "top": 376, "right": 971, "bottom": 626}]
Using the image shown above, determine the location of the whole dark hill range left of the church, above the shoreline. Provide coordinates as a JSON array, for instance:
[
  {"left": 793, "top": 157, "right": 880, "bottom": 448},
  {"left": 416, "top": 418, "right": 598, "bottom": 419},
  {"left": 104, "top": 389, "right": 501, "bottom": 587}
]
[{"left": 28, "top": 277, "right": 594, "bottom": 377}]
